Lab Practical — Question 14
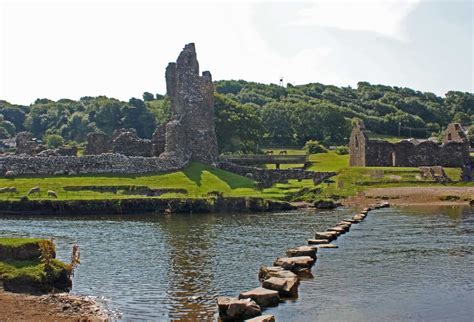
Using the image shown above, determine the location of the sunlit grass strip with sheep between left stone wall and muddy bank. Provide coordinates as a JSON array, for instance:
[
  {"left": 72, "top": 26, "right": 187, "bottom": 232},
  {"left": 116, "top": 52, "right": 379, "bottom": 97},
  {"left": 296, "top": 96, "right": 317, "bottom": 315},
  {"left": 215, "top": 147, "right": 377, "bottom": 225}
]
[{"left": 0, "top": 163, "right": 311, "bottom": 200}]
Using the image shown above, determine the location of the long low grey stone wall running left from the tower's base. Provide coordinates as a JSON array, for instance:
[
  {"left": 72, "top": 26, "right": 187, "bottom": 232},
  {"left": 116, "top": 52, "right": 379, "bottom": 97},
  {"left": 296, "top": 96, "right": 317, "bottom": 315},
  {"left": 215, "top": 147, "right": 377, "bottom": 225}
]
[{"left": 0, "top": 153, "right": 186, "bottom": 176}]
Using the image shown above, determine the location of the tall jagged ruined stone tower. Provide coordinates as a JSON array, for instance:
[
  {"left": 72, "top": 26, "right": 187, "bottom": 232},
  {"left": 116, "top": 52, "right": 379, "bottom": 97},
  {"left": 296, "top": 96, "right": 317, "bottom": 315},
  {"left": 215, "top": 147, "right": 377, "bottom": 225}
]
[{"left": 165, "top": 43, "right": 218, "bottom": 164}]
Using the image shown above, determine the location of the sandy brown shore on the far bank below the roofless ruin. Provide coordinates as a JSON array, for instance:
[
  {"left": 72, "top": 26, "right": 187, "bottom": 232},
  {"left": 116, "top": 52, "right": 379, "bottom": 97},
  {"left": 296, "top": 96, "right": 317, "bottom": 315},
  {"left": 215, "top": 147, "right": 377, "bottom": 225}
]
[{"left": 344, "top": 186, "right": 474, "bottom": 207}]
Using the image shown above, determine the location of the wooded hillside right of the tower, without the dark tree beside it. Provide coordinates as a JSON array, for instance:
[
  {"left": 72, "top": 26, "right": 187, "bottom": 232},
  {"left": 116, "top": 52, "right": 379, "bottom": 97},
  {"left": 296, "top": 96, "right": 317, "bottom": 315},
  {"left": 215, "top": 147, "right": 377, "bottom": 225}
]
[{"left": 215, "top": 80, "right": 474, "bottom": 146}]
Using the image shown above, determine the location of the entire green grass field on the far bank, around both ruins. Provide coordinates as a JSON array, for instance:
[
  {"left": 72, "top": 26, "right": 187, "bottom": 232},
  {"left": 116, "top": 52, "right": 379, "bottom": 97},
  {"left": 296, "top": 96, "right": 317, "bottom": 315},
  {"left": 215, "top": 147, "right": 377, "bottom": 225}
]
[{"left": 0, "top": 149, "right": 471, "bottom": 200}]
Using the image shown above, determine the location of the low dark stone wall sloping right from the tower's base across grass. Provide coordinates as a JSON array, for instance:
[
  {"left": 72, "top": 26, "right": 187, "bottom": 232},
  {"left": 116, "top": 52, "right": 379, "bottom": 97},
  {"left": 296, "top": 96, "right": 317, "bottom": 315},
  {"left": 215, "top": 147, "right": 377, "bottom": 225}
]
[{"left": 219, "top": 162, "right": 336, "bottom": 188}]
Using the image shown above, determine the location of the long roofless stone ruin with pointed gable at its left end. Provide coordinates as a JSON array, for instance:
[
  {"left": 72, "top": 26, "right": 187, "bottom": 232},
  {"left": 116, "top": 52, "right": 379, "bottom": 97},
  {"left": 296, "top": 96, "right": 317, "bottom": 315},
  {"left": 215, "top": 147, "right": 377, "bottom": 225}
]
[{"left": 349, "top": 123, "right": 469, "bottom": 167}]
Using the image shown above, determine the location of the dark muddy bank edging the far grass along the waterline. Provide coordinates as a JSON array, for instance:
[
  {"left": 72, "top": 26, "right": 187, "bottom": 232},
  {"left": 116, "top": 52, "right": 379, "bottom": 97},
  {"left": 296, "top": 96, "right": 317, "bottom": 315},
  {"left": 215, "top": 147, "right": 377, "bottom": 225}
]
[{"left": 0, "top": 198, "right": 295, "bottom": 215}]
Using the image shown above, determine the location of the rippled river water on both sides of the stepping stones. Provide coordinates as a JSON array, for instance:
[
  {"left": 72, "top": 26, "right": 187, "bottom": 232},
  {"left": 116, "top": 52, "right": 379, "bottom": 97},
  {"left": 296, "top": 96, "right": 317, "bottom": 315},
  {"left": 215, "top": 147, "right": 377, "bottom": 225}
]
[{"left": 0, "top": 208, "right": 474, "bottom": 321}]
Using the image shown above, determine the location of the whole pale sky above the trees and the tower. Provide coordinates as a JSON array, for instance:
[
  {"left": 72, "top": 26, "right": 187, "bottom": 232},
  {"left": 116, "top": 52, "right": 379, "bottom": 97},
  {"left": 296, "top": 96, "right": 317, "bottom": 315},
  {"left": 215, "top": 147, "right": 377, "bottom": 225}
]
[{"left": 0, "top": 0, "right": 474, "bottom": 104}]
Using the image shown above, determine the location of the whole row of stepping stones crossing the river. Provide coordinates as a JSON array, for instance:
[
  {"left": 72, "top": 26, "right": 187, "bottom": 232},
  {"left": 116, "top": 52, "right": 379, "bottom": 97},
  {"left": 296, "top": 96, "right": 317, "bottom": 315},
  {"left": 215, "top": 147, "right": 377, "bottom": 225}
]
[{"left": 217, "top": 202, "right": 390, "bottom": 322}]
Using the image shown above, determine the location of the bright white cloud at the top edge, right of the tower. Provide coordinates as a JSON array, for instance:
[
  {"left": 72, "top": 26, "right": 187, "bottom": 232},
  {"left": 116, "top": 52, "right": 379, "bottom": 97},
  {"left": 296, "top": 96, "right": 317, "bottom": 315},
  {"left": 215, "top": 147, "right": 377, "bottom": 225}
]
[{"left": 294, "top": 0, "right": 420, "bottom": 39}]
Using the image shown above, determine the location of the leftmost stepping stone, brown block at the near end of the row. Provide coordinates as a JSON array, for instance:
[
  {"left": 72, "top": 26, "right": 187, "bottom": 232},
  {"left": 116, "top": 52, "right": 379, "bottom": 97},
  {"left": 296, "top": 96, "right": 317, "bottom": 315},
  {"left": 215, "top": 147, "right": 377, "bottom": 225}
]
[{"left": 217, "top": 296, "right": 262, "bottom": 320}]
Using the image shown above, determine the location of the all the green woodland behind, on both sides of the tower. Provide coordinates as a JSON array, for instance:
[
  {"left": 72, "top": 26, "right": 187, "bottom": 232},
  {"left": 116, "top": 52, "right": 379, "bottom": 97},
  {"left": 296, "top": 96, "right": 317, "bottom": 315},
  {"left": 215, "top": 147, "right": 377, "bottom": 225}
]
[{"left": 0, "top": 80, "right": 474, "bottom": 152}]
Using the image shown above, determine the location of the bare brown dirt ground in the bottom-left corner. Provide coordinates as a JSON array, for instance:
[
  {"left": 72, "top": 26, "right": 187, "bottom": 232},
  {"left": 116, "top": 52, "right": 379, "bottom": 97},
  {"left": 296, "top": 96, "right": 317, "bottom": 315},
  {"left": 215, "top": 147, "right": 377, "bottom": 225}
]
[{"left": 0, "top": 289, "right": 107, "bottom": 321}]
